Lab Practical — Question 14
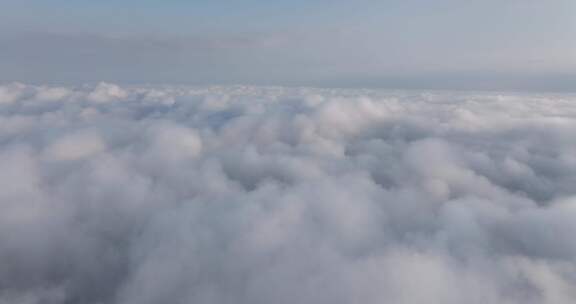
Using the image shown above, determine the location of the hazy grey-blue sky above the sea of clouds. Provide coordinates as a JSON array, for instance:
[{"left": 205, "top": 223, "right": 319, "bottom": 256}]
[{"left": 0, "top": 0, "right": 576, "bottom": 91}]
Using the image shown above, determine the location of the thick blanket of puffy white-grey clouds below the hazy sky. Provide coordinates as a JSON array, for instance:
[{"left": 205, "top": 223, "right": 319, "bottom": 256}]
[{"left": 0, "top": 84, "right": 576, "bottom": 304}]
